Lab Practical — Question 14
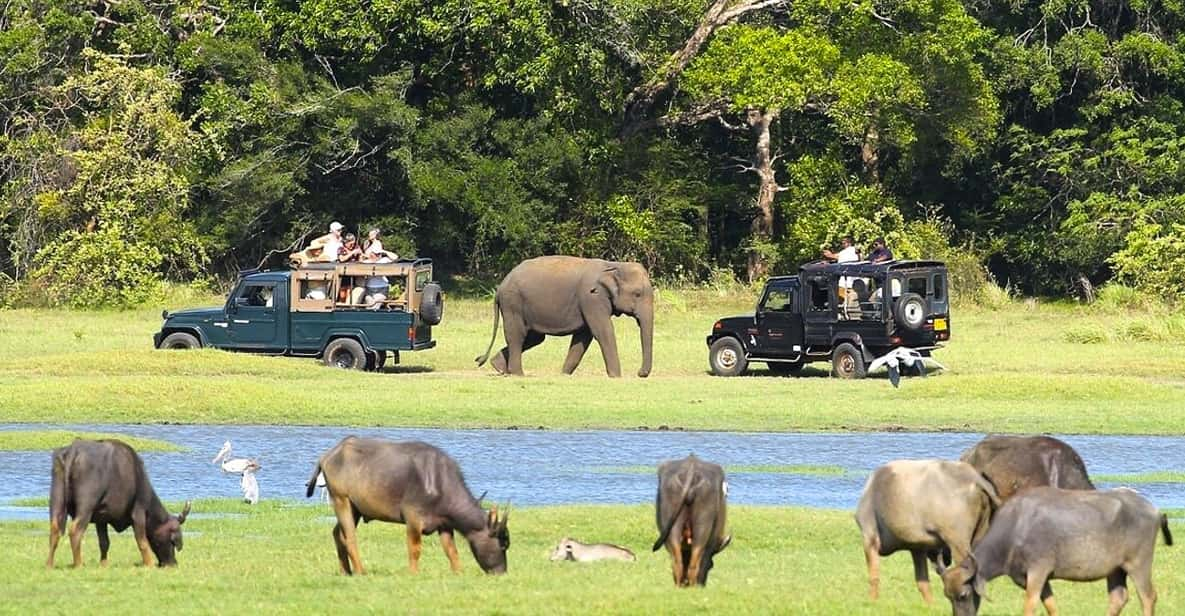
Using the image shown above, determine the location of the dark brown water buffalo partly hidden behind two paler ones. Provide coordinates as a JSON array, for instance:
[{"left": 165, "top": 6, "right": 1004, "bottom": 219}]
[{"left": 960, "top": 436, "right": 1095, "bottom": 500}]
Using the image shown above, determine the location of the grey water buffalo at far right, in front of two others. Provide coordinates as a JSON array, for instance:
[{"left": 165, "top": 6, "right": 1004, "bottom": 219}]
[{"left": 939, "top": 487, "right": 1173, "bottom": 616}]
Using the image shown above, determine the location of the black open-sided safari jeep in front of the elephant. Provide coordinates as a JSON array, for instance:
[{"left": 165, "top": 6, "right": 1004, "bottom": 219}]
[{"left": 707, "top": 261, "right": 950, "bottom": 379}]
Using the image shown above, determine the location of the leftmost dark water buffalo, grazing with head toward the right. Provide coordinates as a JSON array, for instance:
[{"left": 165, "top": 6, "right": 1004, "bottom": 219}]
[{"left": 45, "top": 438, "right": 190, "bottom": 569}]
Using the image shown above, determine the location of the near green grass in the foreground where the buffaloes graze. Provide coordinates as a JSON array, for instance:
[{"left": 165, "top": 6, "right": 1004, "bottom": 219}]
[{"left": 0, "top": 501, "right": 1185, "bottom": 616}]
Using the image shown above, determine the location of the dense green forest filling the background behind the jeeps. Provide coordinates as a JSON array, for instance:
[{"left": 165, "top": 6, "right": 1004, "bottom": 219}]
[{"left": 0, "top": 0, "right": 1185, "bottom": 306}]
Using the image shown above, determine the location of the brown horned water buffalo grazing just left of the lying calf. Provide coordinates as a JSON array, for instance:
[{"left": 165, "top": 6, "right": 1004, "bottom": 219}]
[{"left": 306, "top": 436, "right": 511, "bottom": 575}]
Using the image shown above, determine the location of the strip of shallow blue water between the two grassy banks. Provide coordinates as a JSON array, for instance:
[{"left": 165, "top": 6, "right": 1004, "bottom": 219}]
[{"left": 0, "top": 424, "right": 1185, "bottom": 519}]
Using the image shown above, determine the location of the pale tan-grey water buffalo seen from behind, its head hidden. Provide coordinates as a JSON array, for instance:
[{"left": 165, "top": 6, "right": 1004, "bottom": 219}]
[{"left": 856, "top": 460, "right": 1000, "bottom": 603}]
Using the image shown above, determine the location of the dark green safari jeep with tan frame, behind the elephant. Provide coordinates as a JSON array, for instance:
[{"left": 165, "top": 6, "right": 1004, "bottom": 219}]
[{"left": 153, "top": 258, "right": 444, "bottom": 370}]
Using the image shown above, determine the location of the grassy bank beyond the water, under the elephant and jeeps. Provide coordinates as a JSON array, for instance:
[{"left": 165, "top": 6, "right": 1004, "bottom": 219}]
[{"left": 0, "top": 290, "right": 1185, "bottom": 435}]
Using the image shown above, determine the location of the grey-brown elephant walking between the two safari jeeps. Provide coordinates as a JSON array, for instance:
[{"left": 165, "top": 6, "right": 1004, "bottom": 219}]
[{"left": 475, "top": 255, "right": 654, "bottom": 377}]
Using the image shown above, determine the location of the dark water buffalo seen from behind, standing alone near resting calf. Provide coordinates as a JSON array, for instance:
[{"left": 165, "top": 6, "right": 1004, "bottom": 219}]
[{"left": 653, "top": 455, "right": 732, "bottom": 586}]
